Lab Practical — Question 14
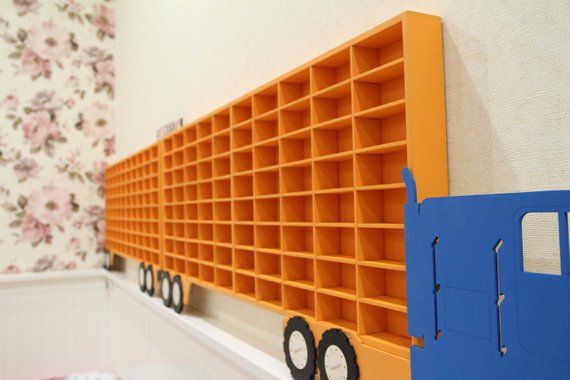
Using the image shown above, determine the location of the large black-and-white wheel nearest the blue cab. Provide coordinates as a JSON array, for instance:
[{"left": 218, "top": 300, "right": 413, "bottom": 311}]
[{"left": 318, "top": 329, "right": 358, "bottom": 380}]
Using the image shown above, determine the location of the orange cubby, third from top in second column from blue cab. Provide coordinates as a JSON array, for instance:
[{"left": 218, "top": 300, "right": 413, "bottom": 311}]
[{"left": 313, "top": 119, "right": 353, "bottom": 157}]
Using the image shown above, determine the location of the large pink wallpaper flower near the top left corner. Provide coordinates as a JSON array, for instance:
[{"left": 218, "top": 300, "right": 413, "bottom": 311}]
[{"left": 26, "top": 21, "right": 73, "bottom": 62}]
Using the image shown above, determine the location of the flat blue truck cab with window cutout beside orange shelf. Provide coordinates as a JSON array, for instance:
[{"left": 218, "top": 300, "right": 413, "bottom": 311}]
[{"left": 403, "top": 169, "right": 570, "bottom": 379}]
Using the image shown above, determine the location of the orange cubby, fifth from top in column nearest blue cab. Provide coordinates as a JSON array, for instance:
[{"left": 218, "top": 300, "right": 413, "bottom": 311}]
[{"left": 356, "top": 189, "right": 406, "bottom": 224}]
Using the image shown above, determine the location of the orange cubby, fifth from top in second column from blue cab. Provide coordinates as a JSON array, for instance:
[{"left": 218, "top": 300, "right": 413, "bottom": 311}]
[{"left": 315, "top": 191, "right": 354, "bottom": 223}]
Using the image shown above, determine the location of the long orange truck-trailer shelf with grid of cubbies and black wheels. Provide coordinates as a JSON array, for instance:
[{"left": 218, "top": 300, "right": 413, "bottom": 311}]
[{"left": 107, "top": 12, "right": 447, "bottom": 379}]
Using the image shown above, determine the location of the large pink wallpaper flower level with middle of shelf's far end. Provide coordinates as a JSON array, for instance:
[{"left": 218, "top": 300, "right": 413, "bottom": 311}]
[{"left": 26, "top": 185, "right": 73, "bottom": 226}]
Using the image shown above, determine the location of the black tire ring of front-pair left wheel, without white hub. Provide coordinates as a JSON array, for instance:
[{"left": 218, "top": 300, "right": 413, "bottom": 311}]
[{"left": 283, "top": 317, "right": 317, "bottom": 380}]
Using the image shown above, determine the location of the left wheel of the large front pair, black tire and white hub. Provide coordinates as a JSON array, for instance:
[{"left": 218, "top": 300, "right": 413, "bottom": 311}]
[{"left": 283, "top": 317, "right": 317, "bottom": 380}]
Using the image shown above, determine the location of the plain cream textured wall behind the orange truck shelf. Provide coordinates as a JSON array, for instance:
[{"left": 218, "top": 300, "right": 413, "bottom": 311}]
[{"left": 117, "top": 0, "right": 570, "bottom": 358}]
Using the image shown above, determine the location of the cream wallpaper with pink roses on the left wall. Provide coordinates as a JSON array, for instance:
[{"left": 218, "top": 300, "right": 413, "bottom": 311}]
[{"left": 0, "top": 0, "right": 115, "bottom": 274}]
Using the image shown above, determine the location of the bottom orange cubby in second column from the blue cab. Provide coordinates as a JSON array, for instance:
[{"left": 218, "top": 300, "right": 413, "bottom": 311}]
[{"left": 316, "top": 293, "right": 357, "bottom": 331}]
